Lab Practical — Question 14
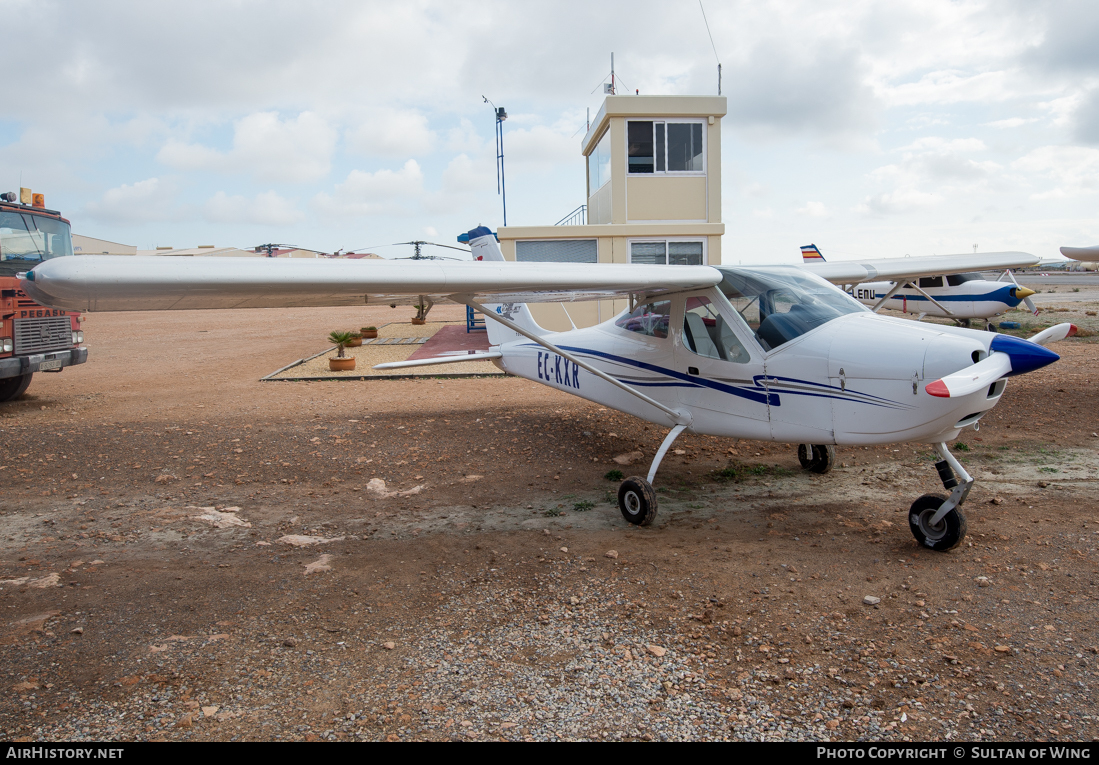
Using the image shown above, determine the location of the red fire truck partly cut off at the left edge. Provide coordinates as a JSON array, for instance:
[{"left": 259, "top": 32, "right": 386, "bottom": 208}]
[{"left": 0, "top": 189, "right": 88, "bottom": 401}]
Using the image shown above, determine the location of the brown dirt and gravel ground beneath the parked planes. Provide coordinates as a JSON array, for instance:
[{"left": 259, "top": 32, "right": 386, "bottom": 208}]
[{"left": 0, "top": 308, "right": 1099, "bottom": 741}]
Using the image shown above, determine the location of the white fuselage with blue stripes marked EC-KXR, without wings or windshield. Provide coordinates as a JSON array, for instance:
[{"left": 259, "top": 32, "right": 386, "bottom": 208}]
[{"left": 489, "top": 288, "right": 1004, "bottom": 444}]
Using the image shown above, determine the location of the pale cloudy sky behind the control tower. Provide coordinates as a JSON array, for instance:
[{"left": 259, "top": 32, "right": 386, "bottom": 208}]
[{"left": 0, "top": 0, "right": 1099, "bottom": 263}]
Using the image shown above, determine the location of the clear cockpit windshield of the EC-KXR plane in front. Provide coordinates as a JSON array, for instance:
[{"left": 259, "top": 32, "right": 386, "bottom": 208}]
[{"left": 718, "top": 266, "right": 869, "bottom": 351}]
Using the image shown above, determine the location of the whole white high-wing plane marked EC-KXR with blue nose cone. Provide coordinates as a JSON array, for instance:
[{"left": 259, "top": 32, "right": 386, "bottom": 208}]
[{"left": 22, "top": 226, "right": 1075, "bottom": 551}]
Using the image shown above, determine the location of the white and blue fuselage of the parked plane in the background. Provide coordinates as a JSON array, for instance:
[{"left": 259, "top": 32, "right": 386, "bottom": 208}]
[{"left": 847, "top": 277, "right": 1022, "bottom": 319}]
